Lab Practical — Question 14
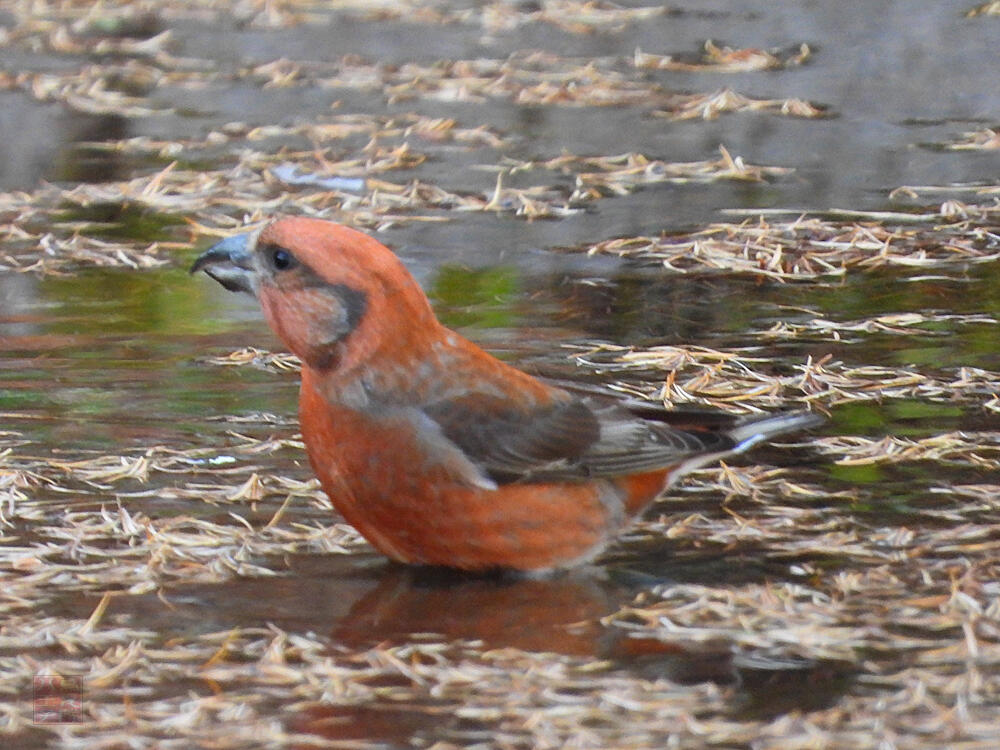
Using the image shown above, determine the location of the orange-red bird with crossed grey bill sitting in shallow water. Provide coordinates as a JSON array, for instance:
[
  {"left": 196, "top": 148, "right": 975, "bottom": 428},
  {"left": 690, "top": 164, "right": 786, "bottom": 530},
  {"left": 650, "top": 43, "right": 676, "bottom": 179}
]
[{"left": 191, "top": 217, "right": 821, "bottom": 570}]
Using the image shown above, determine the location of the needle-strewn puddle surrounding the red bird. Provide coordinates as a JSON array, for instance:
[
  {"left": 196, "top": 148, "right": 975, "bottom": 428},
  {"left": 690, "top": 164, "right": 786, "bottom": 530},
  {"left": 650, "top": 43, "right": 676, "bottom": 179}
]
[{"left": 0, "top": 1, "right": 1000, "bottom": 748}]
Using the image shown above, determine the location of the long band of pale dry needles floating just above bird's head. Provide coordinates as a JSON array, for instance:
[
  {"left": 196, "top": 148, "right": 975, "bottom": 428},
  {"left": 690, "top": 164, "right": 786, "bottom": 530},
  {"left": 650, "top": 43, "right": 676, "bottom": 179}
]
[{"left": 0, "top": 138, "right": 804, "bottom": 274}]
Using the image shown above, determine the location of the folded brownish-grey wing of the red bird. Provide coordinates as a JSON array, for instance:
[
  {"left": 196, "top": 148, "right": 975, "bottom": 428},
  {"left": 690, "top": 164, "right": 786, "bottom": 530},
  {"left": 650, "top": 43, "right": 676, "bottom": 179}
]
[{"left": 424, "top": 390, "right": 733, "bottom": 483}]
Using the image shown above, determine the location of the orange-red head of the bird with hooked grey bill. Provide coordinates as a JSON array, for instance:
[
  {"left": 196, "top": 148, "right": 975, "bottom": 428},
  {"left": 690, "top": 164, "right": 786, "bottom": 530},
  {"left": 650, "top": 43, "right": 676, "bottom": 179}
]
[{"left": 191, "top": 217, "right": 440, "bottom": 371}]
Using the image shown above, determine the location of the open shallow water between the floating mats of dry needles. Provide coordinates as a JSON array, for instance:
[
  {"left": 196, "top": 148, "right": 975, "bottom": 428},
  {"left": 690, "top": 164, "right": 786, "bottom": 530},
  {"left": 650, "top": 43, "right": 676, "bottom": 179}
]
[{"left": 0, "top": 0, "right": 1000, "bottom": 747}]
